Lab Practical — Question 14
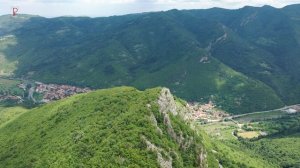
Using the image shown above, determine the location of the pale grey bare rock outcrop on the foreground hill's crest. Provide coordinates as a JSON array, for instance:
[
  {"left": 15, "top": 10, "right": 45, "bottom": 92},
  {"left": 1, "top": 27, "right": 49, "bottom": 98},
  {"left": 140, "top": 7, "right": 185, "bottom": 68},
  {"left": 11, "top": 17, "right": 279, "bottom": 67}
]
[{"left": 142, "top": 88, "right": 208, "bottom": 168}]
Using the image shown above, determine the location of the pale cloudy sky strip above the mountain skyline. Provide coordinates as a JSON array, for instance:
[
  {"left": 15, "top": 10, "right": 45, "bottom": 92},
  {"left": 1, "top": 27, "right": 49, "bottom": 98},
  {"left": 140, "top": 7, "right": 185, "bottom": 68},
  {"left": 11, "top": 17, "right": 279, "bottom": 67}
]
[{"left": 0, "top": 0, "right": 300, "bottom": 17}]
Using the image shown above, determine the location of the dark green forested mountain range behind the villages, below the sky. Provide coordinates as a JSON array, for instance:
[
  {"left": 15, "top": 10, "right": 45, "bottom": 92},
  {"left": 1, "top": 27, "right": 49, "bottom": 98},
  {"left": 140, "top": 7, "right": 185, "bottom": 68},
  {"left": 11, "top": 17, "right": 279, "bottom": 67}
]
[{"left": 0, "top": 5, "right": 300, "bottom": 113}]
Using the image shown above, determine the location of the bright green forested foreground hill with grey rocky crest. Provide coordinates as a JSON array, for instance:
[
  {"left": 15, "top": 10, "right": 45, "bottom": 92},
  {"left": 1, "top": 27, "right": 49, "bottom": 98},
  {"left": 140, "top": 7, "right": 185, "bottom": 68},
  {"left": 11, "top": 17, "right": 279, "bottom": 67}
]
[{"left": 0, "top": 87, "right": 218, "bottom": 168}]
